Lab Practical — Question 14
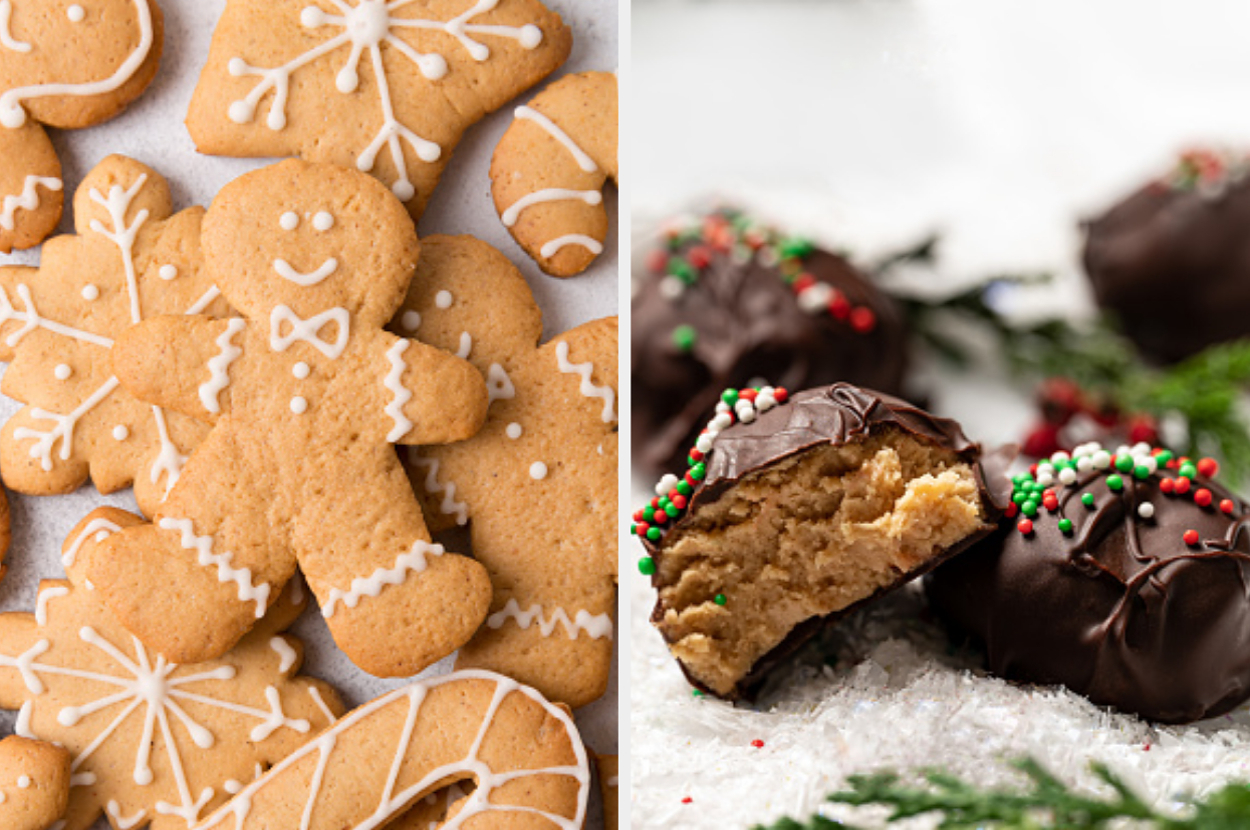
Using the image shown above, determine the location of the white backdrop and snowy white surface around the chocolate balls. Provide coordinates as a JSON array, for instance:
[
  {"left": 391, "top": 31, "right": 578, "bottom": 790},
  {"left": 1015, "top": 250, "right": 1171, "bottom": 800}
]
[{"left": 635, "top": 0, "right": 1250, "bottom": 828}]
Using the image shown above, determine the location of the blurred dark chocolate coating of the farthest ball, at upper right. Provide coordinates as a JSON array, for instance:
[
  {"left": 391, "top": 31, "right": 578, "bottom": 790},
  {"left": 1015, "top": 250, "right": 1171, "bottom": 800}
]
[{"left": 1084, "top": 160, "right": 1250, "bottom": 363}]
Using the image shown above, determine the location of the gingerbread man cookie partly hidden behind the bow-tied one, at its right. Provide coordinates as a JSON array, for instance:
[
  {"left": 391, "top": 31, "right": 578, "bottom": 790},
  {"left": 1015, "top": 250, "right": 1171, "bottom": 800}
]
[{"left": 393, "top": 236, "right": 618, "bottom": 708}]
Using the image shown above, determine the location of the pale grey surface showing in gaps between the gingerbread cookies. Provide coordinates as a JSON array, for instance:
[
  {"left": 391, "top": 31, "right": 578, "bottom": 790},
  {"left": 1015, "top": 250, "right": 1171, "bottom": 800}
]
[{"left": 0, "top": 0, "right": 619, "bottom": 828}]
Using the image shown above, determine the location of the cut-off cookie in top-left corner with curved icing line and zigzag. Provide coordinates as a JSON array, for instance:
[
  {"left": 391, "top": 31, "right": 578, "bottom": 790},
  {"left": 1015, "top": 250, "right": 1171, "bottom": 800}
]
[{"left": 0, "top": 0, "right": 163, "bottom": 254}]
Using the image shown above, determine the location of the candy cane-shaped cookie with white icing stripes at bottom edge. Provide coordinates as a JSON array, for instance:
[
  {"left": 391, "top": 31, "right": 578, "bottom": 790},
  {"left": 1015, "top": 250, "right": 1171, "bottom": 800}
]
[{"left": 196, "top": 671, "right": 590, "bottom": 830}]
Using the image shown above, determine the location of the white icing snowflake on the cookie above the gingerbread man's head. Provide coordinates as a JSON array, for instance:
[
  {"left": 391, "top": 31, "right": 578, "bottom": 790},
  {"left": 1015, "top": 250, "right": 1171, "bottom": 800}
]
[{"left": 228, "top": 0, "right": 543, "bottom": 201}]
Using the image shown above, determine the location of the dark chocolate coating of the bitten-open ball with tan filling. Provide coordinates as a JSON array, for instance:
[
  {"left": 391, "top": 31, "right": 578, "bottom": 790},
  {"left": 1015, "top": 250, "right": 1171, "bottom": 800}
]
[{"left": 643, "top": 383, "right": 1011, "bottom": 698}]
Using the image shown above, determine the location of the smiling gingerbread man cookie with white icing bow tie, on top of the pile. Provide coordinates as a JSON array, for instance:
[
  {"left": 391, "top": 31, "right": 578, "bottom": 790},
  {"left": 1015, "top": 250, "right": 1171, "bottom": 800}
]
[{"left": 91, "top": 161, "right": 490, "bottom": 676}]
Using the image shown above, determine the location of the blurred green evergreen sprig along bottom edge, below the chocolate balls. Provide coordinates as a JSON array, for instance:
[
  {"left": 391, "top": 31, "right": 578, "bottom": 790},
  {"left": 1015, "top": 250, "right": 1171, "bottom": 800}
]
[{"left": 755, "top": 759, "right": 1250, "bottom": 830}]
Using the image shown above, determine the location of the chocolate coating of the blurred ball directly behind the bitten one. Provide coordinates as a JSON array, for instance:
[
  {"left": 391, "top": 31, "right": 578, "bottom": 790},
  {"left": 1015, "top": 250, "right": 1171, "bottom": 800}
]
[{"left": 630, "top": 211, "right": 906, "bottom": 474}]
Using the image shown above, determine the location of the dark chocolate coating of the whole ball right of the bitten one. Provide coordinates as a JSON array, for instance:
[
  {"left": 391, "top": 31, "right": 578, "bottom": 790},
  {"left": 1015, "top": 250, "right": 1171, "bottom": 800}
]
[{"left": 926, "top": 457, "right": 1250, "bottom": 723}]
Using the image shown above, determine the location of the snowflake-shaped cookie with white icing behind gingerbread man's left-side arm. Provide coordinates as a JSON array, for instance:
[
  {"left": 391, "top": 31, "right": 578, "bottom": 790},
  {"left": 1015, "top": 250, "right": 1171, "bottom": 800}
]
[{"left": 0, "top": 156, "right": 228, "bottom": 514}]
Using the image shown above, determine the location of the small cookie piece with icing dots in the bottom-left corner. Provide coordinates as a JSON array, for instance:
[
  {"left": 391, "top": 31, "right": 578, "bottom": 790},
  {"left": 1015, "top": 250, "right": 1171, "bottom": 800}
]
[{"left": 0, "top": 735, "right": 70, "bottom": 830}]
